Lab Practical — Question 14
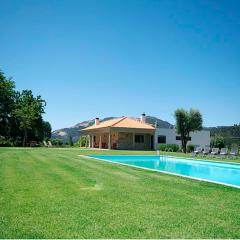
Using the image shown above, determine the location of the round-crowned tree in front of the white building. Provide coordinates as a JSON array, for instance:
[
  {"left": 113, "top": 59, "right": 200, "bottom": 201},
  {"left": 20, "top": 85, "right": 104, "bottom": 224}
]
[{"left": 174, "top": 109, "right": 203, "bottom": 153}]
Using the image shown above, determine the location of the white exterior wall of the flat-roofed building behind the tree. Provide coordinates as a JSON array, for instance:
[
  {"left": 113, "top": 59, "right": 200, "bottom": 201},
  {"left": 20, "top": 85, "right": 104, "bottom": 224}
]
[{"left": 154, "top": 128, "right": 210, "bottom": 149}]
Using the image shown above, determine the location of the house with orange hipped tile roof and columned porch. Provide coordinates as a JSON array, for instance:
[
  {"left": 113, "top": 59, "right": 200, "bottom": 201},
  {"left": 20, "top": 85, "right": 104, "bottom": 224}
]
[{"left": 81, "top": 116, "right": 155, "bottom": 150}]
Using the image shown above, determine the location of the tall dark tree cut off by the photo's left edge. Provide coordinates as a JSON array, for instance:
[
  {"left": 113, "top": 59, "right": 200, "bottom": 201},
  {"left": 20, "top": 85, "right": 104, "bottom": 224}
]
[{"left": 0, "top": 70, "right": 15, "bottom": 137}]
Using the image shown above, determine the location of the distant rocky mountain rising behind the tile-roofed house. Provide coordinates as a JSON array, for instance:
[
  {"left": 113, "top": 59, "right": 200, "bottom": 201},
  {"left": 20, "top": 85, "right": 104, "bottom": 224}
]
[{"left": 52, "top": 116, "right": 173, "bottom": 142}]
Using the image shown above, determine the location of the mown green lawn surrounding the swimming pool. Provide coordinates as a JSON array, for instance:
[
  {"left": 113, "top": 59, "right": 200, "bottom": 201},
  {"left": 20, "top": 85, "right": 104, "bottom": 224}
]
[{"left": 0, "top": 148, "right": 240, "bottom": 238}]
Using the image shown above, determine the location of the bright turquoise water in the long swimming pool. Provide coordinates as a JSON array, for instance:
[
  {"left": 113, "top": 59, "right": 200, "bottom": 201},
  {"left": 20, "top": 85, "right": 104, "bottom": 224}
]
[{"left": 89, "top": 156, "right": 240, "bottom": 188}]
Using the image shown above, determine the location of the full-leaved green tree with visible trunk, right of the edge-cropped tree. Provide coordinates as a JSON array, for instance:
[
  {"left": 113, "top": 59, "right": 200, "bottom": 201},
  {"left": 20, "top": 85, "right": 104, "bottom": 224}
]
[{"left": 13, "top": 90, "right": 46, "bottom": 147}]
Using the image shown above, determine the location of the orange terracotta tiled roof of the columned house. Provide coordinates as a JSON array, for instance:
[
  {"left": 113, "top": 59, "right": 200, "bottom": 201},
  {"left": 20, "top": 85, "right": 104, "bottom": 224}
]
[{"left": 81, "top": 117, "right": 155, "bottom": 131}]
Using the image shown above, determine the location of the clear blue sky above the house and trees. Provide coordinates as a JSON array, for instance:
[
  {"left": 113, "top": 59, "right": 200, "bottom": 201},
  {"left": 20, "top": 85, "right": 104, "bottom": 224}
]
[{"left": 0, "top": 0, "right": 240, "bottom": 129}]
